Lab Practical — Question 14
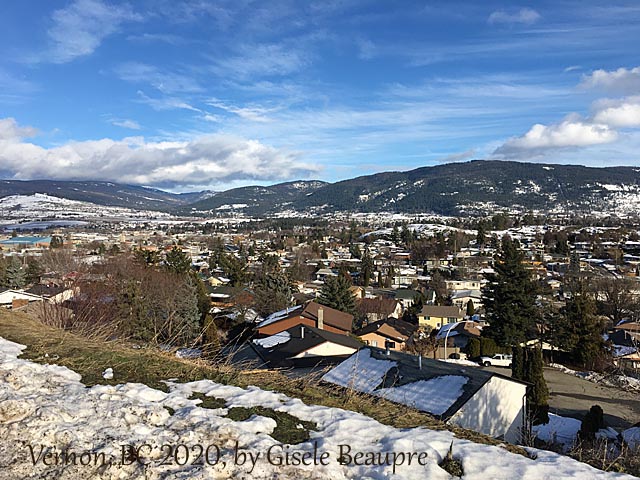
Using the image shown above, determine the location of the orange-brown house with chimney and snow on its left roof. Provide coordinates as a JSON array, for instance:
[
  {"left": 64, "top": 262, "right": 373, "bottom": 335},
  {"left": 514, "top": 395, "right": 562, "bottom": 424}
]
[{"left": 257, "top": 301, "right": 353, "bottom": 336}]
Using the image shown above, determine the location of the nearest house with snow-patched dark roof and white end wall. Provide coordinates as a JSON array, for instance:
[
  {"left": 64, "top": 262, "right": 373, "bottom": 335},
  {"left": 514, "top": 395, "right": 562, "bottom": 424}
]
[{"left": 322, "top": 347, "right": 528, "bottom": 443}]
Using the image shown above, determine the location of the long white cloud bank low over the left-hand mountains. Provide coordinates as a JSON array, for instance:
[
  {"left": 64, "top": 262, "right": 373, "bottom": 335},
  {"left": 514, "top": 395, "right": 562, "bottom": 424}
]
[{"left": 0, "top": 118, "right": 318, "bottom": 187}]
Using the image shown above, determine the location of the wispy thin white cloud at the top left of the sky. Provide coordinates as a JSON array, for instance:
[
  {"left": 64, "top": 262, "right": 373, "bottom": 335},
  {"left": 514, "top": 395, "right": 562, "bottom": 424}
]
[{"left": 47, "top": 0, "right": 141, "bottom": 63}]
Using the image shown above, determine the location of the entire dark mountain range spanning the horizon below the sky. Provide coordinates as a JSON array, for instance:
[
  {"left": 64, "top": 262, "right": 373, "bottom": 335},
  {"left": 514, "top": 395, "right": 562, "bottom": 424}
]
[{"left": 0, "top": 160, "right": 640, "bottom": 216}]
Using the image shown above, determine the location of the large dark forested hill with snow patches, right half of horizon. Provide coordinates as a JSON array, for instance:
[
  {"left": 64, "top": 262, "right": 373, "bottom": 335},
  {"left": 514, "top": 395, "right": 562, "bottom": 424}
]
[{"left": 296, "top": 160, "right": 640, "bottom": 215}]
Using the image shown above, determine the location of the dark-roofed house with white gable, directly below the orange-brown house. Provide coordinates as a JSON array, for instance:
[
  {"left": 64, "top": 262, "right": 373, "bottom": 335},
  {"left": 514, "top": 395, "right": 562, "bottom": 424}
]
[{"left": 250, "top": 324, "right": 362, "bottom": 368}]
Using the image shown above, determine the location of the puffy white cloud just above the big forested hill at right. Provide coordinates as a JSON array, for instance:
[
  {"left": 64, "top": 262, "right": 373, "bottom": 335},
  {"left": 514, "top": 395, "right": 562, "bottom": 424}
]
[{"left": 494, "top": 118, "right": 618, "bottom": 156}]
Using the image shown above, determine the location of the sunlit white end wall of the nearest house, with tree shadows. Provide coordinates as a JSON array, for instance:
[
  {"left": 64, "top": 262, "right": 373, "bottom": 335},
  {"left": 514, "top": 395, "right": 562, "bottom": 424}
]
[{"left": 448, "top": 377, "right": 527, "bottom": 443}]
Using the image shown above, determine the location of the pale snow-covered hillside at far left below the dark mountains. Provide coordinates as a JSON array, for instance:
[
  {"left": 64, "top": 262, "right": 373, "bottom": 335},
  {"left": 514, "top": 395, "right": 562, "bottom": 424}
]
[{"left": 0, "top": 193, "right": 170, "bottom": 222}]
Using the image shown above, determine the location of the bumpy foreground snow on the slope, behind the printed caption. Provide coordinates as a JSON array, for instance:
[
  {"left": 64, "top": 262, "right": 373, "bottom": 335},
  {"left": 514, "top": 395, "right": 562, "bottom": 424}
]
[{"left": 0, "top": 338, "right": 633, "bottom": 480}]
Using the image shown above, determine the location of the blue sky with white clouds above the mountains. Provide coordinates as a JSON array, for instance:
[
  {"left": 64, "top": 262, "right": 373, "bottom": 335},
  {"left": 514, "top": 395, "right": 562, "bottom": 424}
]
[{"left": 0, "top": 0, "right": 640, "bottom": 191}]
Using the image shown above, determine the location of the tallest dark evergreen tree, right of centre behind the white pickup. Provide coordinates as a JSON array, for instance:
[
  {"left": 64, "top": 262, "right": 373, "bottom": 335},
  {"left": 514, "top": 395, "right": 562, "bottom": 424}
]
[{"left": 482, "top": 237, "right": 537, "bottom": 346}]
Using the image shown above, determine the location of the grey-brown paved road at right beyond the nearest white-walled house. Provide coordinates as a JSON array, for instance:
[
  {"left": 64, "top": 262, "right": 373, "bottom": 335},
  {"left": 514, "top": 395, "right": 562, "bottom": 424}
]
[{"left": 486, "top": 367, "right": 640, "bottom": 429}]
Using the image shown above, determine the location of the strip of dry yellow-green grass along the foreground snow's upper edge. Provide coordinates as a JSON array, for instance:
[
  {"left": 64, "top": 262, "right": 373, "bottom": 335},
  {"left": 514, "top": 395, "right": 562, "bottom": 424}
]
[{"left": 0, "top": 310, "right": 527, "bottom": 456}]
